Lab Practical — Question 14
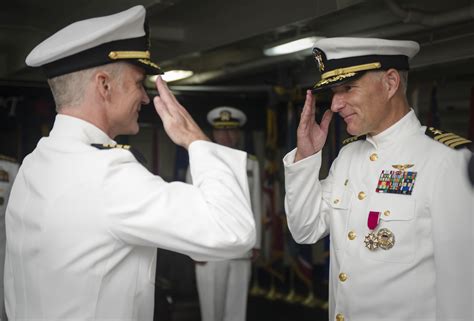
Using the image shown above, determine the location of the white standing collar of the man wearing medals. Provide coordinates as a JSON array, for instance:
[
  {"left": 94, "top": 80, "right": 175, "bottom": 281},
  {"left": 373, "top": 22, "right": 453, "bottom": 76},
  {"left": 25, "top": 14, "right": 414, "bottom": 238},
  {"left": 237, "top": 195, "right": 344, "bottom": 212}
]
[{"left": 367, "top": 109, "right": 421, "bottom": 148}]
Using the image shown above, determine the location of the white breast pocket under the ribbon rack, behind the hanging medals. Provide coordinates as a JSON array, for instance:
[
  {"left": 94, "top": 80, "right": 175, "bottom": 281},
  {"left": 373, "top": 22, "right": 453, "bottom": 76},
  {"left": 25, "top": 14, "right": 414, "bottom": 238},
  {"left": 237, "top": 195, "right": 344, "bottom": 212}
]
[{"left": 362, "top": 194, "right": 416, "bottom": 263}]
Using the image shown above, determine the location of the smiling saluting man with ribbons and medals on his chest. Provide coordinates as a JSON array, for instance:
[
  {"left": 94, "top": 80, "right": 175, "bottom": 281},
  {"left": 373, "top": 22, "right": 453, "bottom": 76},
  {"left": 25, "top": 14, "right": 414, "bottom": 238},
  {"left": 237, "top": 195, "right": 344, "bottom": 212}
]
[{"left": 284, "top": 38, "right": 473, "bottom": 321}]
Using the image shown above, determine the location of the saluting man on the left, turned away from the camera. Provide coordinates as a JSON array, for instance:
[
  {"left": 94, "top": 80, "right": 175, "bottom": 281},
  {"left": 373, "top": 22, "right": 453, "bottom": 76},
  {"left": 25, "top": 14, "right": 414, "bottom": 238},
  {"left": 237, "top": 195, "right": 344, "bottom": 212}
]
[{"left": 5, "top": 6, "right": 255, "bottom": 320}]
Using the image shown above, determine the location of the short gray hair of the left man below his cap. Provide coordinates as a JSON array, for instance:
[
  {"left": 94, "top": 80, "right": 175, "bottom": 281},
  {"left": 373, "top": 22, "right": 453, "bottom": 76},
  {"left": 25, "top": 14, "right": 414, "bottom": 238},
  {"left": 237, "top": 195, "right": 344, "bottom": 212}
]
[{"left": 48, "top": 63, "right": 123, "bottom": 112}]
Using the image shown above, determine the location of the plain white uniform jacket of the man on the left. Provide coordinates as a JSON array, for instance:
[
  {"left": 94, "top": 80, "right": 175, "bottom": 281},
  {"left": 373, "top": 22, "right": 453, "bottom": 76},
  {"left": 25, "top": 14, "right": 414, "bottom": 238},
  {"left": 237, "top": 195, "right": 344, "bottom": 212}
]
[{"left": 5, "top": 115, "right": 255, "bottom": 321}]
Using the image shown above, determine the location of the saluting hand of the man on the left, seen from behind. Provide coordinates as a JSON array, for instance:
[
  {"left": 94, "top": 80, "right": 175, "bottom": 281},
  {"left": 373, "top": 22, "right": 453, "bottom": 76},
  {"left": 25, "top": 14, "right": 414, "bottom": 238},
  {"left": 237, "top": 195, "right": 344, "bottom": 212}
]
[{"left": 153, "top": 76, "right": 210, "bottom": 149}]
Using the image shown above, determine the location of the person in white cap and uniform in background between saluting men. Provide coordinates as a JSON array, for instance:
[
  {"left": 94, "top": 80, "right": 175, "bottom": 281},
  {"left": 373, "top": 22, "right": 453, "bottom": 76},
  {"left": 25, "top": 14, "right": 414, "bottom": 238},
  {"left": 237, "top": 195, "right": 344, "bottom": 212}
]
[{"left": 186, "top": 106, "right": 262, "bottom": 321}]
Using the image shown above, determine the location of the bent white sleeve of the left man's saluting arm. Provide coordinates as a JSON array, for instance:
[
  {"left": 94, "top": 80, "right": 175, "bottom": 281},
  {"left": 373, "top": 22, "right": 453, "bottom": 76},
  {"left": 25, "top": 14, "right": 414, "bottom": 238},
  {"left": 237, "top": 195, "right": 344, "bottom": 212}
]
[{"left": 103, "top": 141, "right": 255, "bottom": 261}]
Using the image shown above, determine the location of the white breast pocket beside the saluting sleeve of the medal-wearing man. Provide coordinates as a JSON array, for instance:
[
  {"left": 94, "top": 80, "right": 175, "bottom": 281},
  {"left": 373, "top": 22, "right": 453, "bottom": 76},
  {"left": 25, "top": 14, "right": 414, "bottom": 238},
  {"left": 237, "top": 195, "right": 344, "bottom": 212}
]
[{"left": 325, "top": 184, "right": 353, "bottom": 251}]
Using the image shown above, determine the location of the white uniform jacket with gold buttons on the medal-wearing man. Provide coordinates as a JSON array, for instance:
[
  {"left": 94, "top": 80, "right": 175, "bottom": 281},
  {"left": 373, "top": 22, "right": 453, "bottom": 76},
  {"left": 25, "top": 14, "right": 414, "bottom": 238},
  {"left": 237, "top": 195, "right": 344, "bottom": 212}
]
[{"left": 284, "top": 111, "right": 474, "bottom": 321}]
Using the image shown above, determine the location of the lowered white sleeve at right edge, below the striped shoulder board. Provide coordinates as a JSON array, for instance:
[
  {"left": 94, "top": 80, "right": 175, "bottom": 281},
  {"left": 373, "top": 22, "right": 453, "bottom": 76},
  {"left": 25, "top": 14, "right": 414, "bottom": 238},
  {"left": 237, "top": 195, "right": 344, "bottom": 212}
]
[{"left": 429, "top": 150, "right": 474, "bottom": 321}]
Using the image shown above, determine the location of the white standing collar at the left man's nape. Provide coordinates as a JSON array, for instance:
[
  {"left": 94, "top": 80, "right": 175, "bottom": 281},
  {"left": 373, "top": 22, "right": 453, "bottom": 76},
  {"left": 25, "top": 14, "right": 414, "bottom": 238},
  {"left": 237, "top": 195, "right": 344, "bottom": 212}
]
[{"left": 50, "top": 114, "right": 116, "bottom": 144}]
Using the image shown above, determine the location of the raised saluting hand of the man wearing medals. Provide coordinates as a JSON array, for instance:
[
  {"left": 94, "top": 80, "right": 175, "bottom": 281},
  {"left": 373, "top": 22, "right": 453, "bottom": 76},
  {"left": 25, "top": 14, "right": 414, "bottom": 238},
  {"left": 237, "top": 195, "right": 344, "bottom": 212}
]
[{"left": 295, "top": 90, "right": 332, "bottom": 162}]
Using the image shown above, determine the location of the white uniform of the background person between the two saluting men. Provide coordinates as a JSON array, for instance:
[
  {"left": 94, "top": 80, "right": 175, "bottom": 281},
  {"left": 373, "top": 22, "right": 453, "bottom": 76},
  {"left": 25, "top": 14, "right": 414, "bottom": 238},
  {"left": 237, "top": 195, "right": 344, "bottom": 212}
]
[{"left": 186, "top": 156, "right": 262, "bottom": 321}]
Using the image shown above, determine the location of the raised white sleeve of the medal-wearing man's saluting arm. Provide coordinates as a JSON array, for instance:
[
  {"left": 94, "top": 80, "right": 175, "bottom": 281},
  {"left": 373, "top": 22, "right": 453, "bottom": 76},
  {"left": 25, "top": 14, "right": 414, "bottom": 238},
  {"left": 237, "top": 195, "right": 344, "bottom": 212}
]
[{"left": 283, "top": 149, "right": 334, "bottom": 244}]
